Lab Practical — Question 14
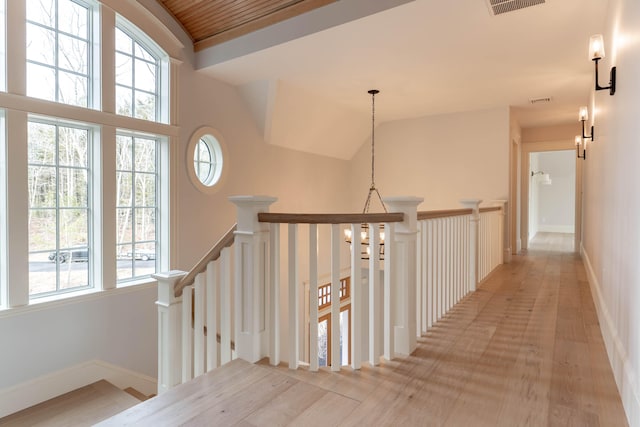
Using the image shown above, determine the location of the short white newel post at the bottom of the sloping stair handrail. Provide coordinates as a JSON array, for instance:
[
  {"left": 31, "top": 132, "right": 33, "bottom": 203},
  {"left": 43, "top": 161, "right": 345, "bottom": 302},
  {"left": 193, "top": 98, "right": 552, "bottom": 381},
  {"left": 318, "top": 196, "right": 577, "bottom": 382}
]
[{"left": 152, "top": 270, "right": 187, "bottom": 394}]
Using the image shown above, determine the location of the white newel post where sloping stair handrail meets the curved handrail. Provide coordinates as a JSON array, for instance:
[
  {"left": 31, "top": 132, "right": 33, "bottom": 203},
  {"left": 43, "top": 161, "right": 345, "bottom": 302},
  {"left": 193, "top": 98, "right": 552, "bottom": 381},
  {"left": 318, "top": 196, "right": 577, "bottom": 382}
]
[{"left": 229, "top": 196, "right": 277, "bottom": 363}]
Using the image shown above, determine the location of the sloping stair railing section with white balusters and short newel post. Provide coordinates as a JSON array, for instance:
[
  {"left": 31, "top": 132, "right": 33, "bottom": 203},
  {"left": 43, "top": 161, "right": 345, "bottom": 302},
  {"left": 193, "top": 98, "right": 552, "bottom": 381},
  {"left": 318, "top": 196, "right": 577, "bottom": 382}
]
[{"left": 154, "top": 224, "right": 237, "bottom": 394}]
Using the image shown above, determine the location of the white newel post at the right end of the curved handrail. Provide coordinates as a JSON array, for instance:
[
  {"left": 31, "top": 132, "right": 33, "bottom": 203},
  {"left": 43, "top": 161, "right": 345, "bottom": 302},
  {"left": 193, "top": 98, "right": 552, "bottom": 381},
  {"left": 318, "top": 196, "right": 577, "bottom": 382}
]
[{"left": 384, "top": 197, "right": 424, "bottom": 355}]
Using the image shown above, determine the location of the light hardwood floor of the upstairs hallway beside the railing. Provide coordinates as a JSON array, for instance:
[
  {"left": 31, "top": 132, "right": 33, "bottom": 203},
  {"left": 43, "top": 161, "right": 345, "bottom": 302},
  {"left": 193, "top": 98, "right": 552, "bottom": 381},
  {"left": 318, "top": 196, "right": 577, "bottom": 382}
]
[{"left": 101, "top": 236, "right": 627, "bottom": 427}]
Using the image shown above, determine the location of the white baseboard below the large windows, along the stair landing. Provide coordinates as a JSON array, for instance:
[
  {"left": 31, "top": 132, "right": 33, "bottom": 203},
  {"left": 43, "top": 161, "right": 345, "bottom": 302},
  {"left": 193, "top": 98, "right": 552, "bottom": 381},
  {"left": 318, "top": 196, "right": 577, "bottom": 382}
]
[{"left": 0, "top": 360, "right": 157, "bottom": 418}]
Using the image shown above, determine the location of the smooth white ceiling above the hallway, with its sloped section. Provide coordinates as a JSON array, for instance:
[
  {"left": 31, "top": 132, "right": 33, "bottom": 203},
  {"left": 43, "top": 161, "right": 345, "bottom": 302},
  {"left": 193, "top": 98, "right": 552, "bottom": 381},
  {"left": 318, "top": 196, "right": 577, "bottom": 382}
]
[{"left": 196, "top": 0, "right": 607, "bottom": 159}]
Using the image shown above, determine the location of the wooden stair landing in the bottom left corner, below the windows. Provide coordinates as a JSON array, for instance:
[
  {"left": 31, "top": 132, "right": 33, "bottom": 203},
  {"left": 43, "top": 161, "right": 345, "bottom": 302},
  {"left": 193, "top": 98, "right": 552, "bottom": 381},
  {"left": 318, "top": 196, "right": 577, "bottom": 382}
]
[{"left": 0, "top": 380, "right": 140, "bottom": 427}]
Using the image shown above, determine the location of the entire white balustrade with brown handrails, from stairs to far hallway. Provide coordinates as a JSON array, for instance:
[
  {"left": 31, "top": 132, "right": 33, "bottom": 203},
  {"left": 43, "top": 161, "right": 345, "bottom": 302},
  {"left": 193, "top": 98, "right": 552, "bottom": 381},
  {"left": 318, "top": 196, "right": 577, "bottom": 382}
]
[{"left": 156, "top": 197, "right": 504, "bottom": 393}]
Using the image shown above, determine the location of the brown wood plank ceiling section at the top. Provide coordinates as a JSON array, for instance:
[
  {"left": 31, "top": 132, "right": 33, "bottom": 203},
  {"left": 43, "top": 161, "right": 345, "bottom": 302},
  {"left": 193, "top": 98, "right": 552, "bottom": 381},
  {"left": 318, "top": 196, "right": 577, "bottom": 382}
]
[{"left": 158, "top": 0, "right": 337, "bottom": 51}]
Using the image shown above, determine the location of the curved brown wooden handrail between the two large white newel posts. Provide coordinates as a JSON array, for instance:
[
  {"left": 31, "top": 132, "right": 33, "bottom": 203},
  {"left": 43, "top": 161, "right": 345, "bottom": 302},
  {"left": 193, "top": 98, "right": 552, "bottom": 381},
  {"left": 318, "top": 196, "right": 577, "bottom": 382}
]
[{"left": 258, "top": 212, "right": 404, "bottom": 224}]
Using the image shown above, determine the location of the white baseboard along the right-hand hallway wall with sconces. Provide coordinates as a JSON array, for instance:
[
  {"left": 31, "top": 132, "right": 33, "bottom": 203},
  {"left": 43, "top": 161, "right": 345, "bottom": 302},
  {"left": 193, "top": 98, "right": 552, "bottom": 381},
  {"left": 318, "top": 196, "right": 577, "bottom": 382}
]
[{"left": 580, "top": 244, "right": 640, "bottom": 427}]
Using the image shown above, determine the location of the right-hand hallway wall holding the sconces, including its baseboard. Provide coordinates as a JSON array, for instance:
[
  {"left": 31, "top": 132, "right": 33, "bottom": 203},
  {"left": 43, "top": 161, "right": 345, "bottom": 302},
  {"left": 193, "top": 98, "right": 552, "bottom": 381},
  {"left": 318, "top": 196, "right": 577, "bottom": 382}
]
[{"left": 583, "top": 0, "right": 640, "bottom": 426}]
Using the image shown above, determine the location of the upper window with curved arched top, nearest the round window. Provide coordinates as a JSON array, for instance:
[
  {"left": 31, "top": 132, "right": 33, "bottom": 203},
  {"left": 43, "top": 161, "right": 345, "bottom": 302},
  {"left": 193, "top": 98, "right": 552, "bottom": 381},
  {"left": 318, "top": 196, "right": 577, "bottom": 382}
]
[{"left": 116, "top": 27, "right": 160, "bottom": 121}]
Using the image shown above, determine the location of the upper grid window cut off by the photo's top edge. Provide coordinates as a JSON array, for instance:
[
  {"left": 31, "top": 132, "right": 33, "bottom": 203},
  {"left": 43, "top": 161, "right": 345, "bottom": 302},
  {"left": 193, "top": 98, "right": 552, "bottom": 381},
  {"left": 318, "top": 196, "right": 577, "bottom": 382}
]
[{"left": 26, "top": 0, "right": 92, "bottom": 107}]
